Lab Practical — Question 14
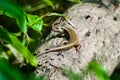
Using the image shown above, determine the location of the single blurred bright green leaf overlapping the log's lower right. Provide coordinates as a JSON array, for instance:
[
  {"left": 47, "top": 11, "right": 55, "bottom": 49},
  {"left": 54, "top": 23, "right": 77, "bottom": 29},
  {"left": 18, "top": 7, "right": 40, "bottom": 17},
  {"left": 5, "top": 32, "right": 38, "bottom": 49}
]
[{"left": 89, "top": 61, "right": 110, "bottom": 80}]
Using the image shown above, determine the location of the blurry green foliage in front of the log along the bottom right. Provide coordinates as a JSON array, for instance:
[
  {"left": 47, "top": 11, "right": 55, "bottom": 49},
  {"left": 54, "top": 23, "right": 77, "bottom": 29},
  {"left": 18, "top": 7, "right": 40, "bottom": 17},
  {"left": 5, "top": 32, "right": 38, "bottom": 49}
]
[{"left": 62, "top": 61, "right": 110, "bottom": 80}]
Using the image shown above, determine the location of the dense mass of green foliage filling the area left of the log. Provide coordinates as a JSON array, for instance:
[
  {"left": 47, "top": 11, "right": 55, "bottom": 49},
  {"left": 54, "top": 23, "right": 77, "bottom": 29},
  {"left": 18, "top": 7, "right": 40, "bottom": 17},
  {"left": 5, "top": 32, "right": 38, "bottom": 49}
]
[{"left": 0, "top": 0, "right": 81, "bottom": 80}]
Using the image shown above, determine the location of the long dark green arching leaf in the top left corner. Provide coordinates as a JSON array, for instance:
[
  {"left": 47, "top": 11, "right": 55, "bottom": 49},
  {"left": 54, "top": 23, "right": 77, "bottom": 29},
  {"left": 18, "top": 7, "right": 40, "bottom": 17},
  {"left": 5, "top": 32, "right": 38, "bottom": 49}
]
[{"left": 0, "top": 0, "right": 27, "bottom": 33}]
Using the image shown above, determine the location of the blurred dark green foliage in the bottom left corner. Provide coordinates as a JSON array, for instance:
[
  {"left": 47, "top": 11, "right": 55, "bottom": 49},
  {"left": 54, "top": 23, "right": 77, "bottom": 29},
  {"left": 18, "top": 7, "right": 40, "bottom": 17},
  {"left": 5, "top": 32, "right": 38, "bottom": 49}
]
[{"left": 0, "top": 58, "right": 46, "bottom": 80}]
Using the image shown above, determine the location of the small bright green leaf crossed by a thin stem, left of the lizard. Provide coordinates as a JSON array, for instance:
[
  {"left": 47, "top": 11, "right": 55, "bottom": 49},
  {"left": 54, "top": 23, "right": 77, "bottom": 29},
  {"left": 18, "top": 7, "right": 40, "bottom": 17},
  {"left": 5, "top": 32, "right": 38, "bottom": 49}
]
[{"left": 27, "top": 14, "right": 43, "bottom": 33}]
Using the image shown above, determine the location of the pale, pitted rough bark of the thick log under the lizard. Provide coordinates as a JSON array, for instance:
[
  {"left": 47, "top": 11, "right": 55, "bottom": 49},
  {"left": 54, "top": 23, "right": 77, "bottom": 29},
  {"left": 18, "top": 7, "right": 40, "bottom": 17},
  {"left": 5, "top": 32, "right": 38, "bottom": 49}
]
[{"left": 35, "top": 0, "right": 120, "bottom": 80}]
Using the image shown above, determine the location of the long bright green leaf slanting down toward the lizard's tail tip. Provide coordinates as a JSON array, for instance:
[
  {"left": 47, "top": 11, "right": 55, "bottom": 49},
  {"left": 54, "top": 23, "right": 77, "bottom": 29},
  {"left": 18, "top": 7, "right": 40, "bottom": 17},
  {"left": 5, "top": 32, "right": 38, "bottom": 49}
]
[{"left": 0, "top": 27, "right": 38, "bottom": 67}]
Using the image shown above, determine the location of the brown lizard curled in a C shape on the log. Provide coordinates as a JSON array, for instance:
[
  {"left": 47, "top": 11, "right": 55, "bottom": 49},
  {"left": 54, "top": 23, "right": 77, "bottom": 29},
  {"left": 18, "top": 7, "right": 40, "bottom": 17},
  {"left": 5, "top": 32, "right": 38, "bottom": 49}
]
[{"left": 37, "top": 26, "right": 81, "bottom": 56}]
